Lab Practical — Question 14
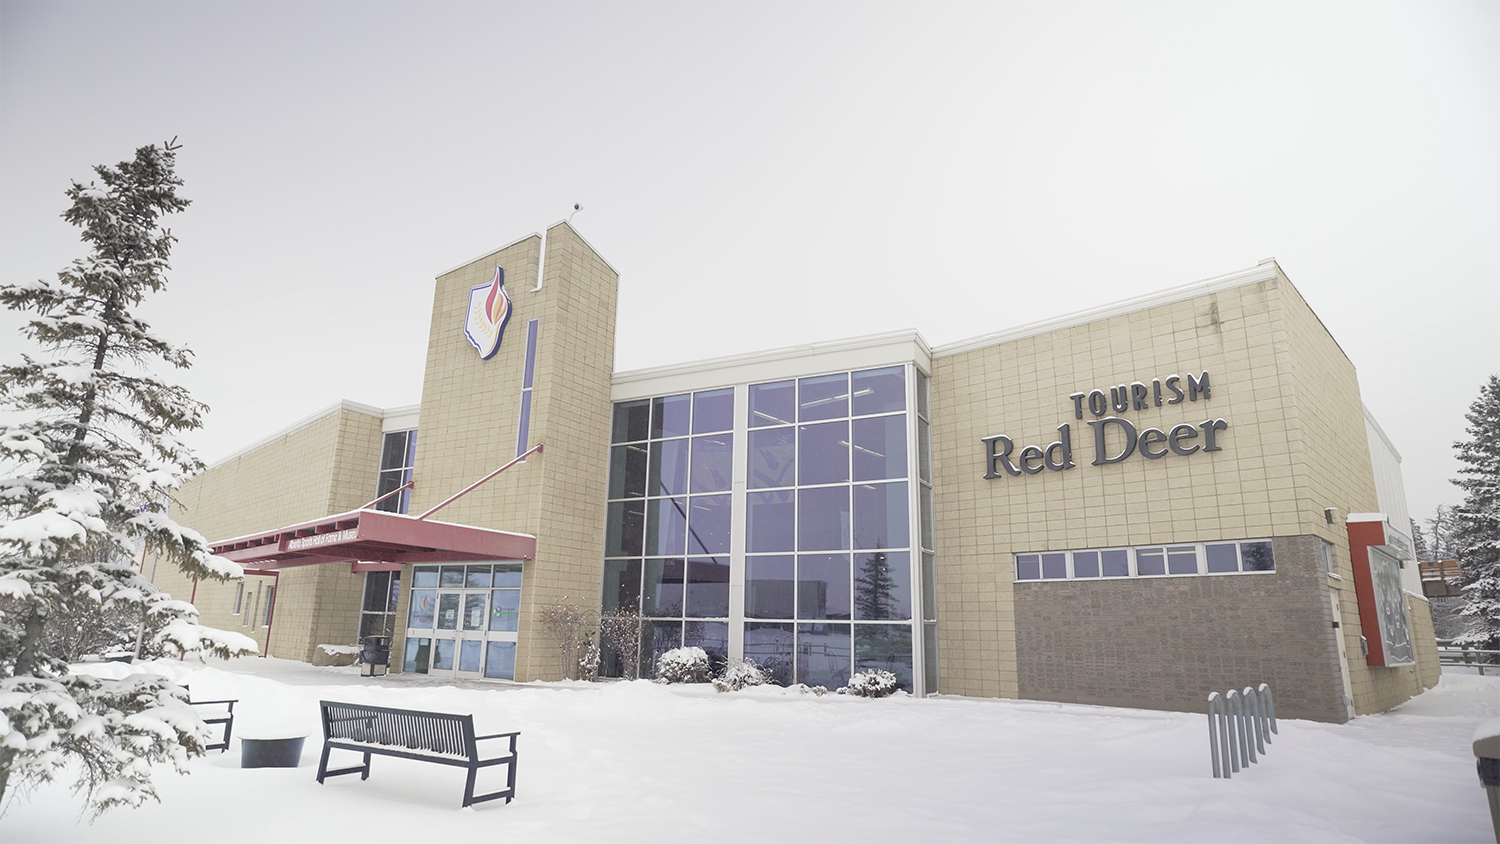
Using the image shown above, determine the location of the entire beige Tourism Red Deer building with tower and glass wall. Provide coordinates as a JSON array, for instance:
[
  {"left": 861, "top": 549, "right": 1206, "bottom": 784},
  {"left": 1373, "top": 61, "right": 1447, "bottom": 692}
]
[{"left": 149, "top": 223, "right": 1439, "bottom": 721}]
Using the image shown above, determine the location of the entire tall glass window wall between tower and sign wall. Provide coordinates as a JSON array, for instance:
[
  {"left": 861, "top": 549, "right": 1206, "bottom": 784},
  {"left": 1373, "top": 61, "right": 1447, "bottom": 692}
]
[{"left": 602, "top": 366, "right": 936, "bottom": 691}]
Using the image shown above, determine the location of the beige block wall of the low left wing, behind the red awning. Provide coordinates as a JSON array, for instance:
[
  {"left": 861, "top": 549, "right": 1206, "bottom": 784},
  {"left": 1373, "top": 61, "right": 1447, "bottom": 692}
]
[{"left": 155, "top": 408, "right": 381, "bottom": 661}]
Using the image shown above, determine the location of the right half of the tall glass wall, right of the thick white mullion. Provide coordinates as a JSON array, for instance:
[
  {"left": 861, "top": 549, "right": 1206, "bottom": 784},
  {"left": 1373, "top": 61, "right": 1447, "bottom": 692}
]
[{"left": 744, "top": 366, "right": 914, "bottom": 690}]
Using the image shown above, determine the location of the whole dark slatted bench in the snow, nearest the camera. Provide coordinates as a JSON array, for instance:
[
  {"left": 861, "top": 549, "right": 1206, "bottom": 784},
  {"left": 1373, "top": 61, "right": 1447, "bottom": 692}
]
[{"left": 318, "top": 700, "right": 521, "bottom": 807}]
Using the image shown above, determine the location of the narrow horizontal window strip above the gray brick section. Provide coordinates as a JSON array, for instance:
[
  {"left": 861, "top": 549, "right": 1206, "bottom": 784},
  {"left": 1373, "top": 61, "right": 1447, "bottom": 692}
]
[{"left": 1016, "top": 540, "right": 1272, "bottom": 580}]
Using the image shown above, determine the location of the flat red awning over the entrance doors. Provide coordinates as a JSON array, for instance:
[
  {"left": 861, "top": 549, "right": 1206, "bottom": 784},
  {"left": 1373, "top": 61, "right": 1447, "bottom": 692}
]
[{"left": 210, "top": 510, "right": 537, "bottom": 571}]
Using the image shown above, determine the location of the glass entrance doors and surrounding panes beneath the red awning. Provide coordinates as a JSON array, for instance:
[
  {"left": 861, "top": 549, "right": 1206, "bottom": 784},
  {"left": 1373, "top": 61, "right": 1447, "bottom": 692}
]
[{"left": 402, "top": 562, "right": 521, "bottom": 681}]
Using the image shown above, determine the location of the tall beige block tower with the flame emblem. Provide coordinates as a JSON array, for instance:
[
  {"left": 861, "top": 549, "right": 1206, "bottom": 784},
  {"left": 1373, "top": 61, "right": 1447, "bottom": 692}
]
[{"left": 393, "top": 223, "right": 618, "bottom": 681}]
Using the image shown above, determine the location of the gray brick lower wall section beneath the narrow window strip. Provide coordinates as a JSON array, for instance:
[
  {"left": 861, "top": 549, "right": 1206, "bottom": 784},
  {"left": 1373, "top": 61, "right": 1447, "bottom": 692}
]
[{"left": 1004, "top": 537, "right": 1346, "bottom": 723}]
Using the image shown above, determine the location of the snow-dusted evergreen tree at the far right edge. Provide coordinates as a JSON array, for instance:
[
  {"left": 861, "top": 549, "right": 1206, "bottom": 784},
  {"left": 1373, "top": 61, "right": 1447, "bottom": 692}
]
[{"left": 1454, "top": 375, "right": 1500, "bottom": 649}]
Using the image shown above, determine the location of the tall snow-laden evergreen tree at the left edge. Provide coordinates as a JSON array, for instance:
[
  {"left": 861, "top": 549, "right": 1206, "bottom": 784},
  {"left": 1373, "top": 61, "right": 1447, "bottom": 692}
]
[{"left": 0, "top": 144, "right": 255, "bottom": 813}]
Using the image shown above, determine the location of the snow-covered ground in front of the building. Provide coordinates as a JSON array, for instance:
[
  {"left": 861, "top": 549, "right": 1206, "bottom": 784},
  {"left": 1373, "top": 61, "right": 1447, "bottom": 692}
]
[{"left": 0, "top": 658, "right": 1500, "bottom": 844}]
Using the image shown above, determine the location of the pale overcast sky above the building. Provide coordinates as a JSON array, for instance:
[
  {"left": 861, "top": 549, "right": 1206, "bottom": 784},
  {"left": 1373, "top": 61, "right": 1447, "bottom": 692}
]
[{"left": 0, "top": 0, "right": 1500, "bottom": 527}]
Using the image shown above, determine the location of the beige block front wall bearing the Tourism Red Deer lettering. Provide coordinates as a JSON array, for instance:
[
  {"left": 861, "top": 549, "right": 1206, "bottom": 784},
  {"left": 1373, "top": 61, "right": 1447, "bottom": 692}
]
[{"left": 933, "top": 282, "right": 1302, "bottom": 697}]
